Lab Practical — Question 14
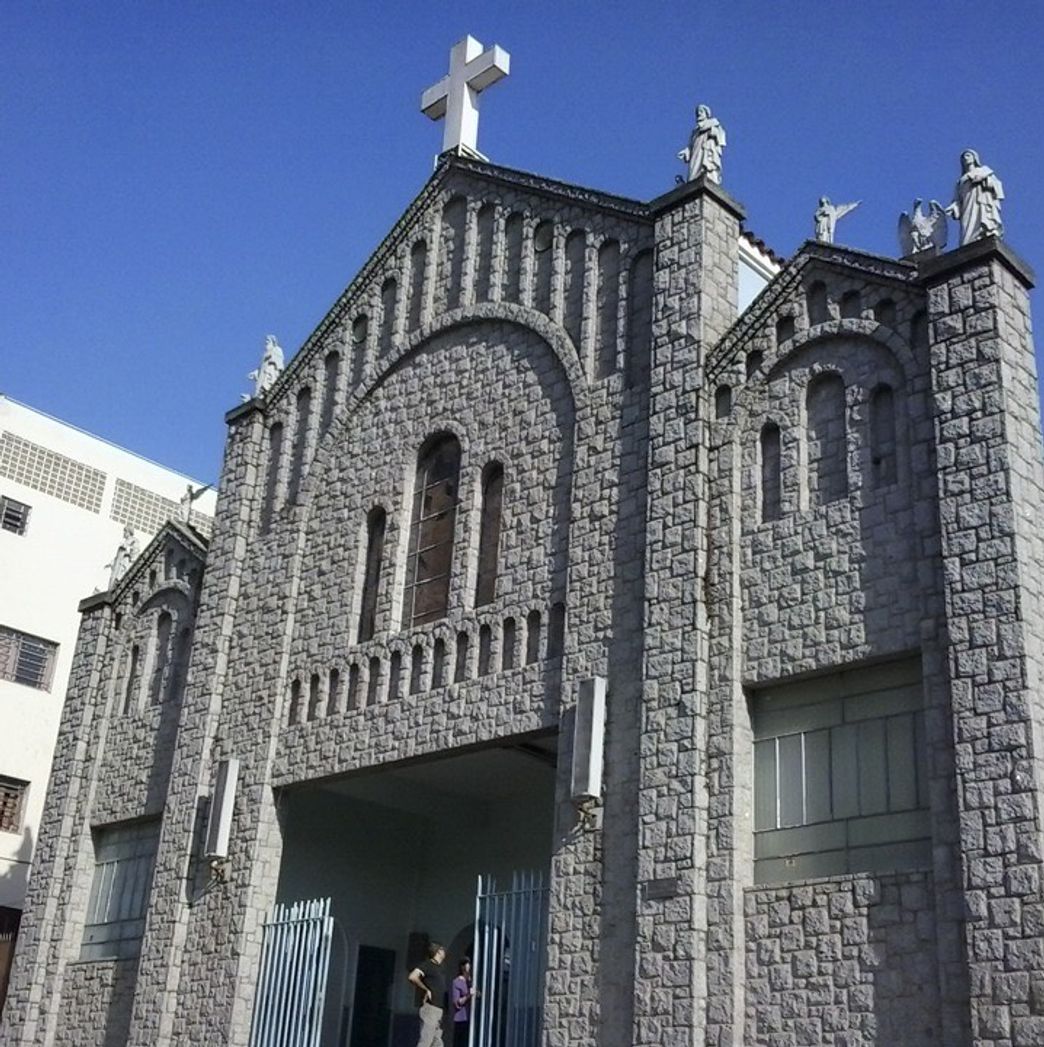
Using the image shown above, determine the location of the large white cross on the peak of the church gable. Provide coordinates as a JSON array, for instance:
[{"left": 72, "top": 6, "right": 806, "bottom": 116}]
[{"left": 421, "top": 36, "right": 511, "bottom": 159}]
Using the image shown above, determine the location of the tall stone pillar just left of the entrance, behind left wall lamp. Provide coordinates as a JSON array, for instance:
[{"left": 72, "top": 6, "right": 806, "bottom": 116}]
[{"left": 128, "top": 400, "right": 267, "bottom": 1045}]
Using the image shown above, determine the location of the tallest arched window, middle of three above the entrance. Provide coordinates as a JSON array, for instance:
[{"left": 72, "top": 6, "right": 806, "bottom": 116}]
[{"left": 403, "top": 432, "right": 461, "bottom": 628}]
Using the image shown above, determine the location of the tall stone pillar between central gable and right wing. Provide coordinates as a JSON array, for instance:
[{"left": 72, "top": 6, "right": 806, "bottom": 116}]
[{"left": 634, "top": 179, "right": 742, "bottom": 1047}]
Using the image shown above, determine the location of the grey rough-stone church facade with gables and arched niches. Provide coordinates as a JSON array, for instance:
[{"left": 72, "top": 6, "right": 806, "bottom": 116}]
[{"left": 2, "top": 149, "right": 1044, "bottom": 1047}]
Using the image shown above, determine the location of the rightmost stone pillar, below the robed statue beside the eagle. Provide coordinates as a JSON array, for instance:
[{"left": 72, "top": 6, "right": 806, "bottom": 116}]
[{"left": 920, "top": 239, "right": 1044, "bottom": 1047}]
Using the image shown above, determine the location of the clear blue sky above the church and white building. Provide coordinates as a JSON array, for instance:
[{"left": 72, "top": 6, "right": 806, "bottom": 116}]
[{"left": 0, "top": 0, "right": 1044, "bottom": 480}]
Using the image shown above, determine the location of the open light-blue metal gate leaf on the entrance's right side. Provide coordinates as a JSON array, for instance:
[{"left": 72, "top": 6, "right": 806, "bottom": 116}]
[{"left": 468, "top": 872, "right": 548, "bottom": 1047}]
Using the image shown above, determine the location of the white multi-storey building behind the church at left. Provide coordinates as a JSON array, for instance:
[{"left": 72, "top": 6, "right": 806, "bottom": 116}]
[{"left": 0, "top": 395, "right": 215, "bottom": 1006}]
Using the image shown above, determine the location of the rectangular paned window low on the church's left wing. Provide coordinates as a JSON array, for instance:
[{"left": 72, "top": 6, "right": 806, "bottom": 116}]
[{"left": 80, "top": 821, "right": 159, "bottom": 960}]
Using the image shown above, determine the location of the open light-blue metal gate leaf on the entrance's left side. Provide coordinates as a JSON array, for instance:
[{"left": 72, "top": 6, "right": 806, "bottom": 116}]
[{"left": 250, "top": 898, "right": 334, "bottom": 1047}]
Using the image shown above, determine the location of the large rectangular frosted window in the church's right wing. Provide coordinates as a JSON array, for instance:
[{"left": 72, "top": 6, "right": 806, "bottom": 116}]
[{"left": 751, "top": 659, "right": 931, "bottom": 884}]
